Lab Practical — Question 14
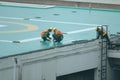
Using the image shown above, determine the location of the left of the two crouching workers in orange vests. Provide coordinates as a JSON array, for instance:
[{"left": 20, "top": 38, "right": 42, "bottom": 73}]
[{"left": 41, "top": 28, "right": 52, "bottom": 41}]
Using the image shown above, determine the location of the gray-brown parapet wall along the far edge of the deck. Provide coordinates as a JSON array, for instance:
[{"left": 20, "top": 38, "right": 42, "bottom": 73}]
[{"left": 1, "top": 0, "right": 120, "bottom": 9}]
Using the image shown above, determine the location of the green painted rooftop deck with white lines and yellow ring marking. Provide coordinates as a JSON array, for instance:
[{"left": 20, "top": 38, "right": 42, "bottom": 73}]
[{"left": 0, "top": 4, "right": 120, "bottom": 58}]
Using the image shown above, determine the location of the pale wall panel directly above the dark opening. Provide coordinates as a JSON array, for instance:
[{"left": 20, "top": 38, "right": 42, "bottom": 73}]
[{"left": 57, "top": 53, "right": 99, "bottom": 76}]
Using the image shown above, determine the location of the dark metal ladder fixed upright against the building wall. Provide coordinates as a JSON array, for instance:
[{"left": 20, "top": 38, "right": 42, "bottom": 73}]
[{"left": 101, "top": 25, "right": 108, "bottom": 80}]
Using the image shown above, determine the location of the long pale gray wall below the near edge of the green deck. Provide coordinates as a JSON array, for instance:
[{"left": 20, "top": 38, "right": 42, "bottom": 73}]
[{"left": 0, "top": 41, "right": 120, "bottom": 80}]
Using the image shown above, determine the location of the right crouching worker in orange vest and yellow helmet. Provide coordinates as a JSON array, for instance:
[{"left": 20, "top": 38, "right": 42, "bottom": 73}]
[{"left": 52, "top": 28, "right": 63, "bottom": 42}]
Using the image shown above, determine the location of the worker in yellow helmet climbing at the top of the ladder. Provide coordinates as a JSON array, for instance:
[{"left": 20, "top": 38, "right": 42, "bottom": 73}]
[{"left": 96, "top": 26, "right": 110, "bottom": 44}]
